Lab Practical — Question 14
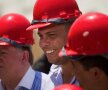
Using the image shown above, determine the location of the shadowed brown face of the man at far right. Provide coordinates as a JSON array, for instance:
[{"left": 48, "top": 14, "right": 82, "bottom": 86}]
[{"left": 72, "top": 61, "right": 95, "bottom": 90}]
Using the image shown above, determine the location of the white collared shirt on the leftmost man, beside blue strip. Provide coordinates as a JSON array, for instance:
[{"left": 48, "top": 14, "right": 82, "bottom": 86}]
[{"left": 0, "top": 67, "right": 47, "bottom": 90}]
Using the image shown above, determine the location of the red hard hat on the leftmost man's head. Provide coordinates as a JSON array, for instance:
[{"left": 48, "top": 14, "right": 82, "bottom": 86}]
[{"left": 0, "top": 13, "right": 34, "bottom": 45}]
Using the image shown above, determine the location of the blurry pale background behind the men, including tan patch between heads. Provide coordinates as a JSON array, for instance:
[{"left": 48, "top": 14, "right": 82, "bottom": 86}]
[{"left": 0, "top": 0, "right": 108, "bottom": 60}]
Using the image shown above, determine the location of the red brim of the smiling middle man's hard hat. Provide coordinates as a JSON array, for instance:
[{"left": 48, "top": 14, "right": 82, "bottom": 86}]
[{"left": 26, "top": 23, "right": 51, "bottom": 30}]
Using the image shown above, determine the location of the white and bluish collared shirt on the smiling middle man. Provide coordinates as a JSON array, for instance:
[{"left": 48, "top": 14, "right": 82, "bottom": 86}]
[{"left": 46, "top": 64, "right": 79, "bottom": 90}]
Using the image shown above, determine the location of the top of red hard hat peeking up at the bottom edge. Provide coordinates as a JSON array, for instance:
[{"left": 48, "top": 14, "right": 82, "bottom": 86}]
[{"left": 54, "top": 84, "right": 83, "bottom": 90}]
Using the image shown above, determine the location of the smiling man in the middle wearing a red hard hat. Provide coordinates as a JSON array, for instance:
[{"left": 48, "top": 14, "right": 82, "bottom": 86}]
[{"left": 27, "top": 0, "right": 81, "bottom": 89}]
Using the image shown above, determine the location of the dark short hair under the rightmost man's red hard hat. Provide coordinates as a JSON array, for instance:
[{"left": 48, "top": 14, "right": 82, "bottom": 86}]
[{"left": 78, "top": 55, "right": 108, "bottom": 76}]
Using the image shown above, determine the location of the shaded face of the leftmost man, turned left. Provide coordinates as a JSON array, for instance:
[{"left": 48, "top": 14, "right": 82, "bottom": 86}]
[{"left": 0, "top": 46, "right": 22, "bottom": 79}]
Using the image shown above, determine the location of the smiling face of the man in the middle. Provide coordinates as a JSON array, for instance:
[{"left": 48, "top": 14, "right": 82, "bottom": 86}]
[{"left": 38, "top": 25, "right": 67, "bottom": 64}]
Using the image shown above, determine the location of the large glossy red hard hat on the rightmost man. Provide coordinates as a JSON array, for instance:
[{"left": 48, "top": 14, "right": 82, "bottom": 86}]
[{"left": 59, "top": 12, "right": 108, "bottom": 56}]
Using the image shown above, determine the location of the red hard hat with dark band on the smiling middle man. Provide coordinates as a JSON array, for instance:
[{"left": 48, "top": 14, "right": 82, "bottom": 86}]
[{"left": 27, "top": 0, "right": 81, "bottom": 30}]
